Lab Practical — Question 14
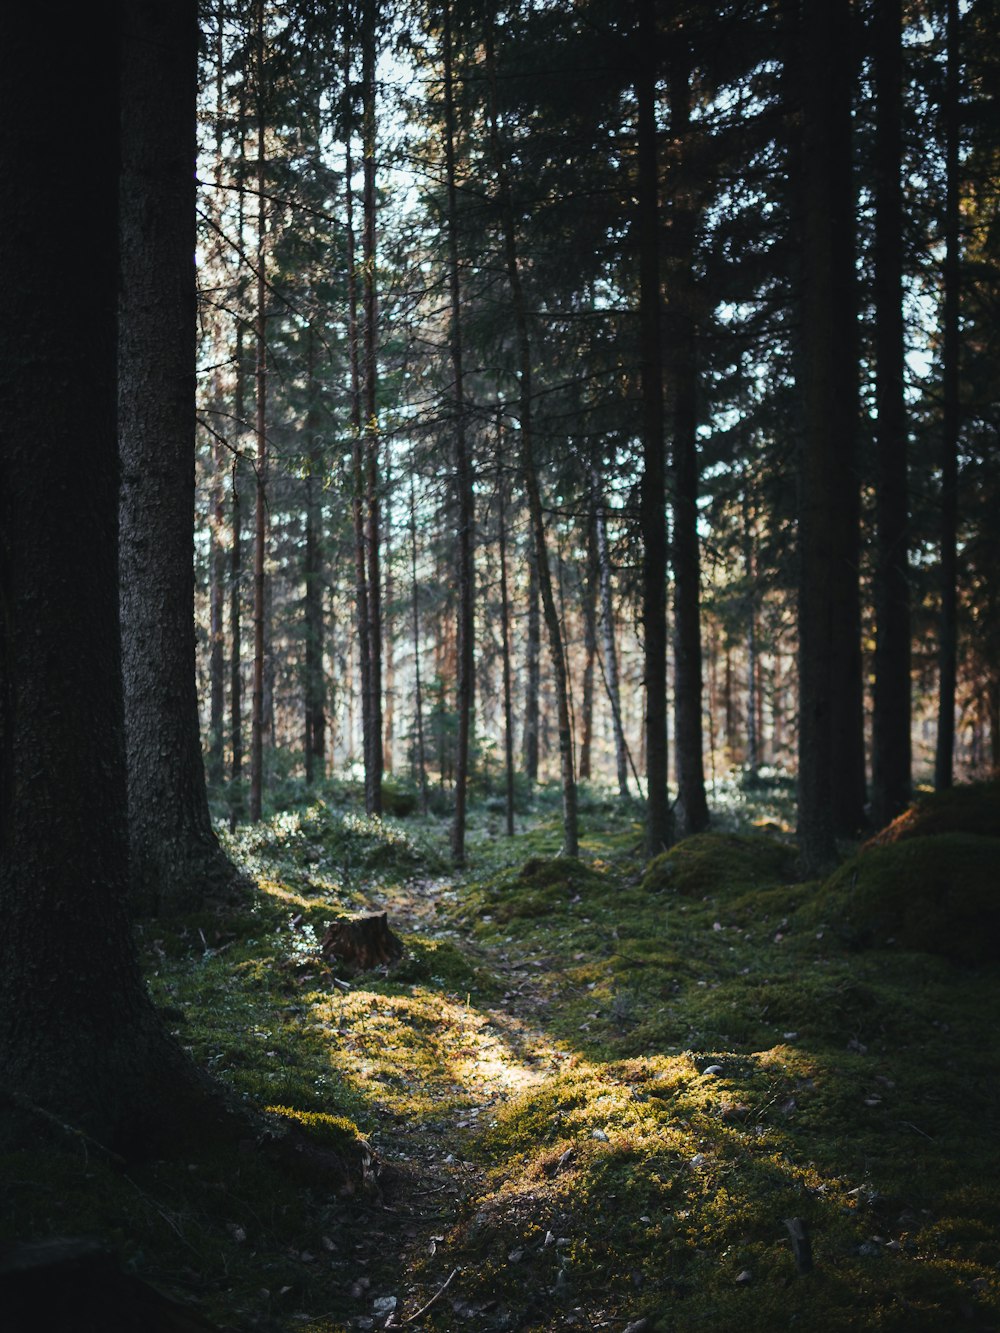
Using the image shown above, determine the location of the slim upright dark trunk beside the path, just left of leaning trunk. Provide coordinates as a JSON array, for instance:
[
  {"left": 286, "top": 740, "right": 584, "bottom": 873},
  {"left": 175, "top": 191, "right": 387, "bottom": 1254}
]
[{"left": 443, "top": 0, "right": 475, "bottom": 866}]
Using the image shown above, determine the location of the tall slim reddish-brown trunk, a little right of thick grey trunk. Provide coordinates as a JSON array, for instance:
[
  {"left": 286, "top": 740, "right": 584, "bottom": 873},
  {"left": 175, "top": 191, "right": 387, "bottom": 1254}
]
[{"left": 249, "top": 0, "right": 268, "bottom": 824}]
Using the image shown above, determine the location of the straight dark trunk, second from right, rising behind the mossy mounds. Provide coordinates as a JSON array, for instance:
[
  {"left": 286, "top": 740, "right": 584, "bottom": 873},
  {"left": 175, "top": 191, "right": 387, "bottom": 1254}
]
[{"left": 872, "top": 0, "right": 911, "bottom": 828}]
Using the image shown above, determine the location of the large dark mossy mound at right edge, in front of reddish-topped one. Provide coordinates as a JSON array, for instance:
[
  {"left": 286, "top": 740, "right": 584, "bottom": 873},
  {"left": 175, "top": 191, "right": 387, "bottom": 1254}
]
[{"left": 799, "top": 833, "right": 1000, "bottom": 964}]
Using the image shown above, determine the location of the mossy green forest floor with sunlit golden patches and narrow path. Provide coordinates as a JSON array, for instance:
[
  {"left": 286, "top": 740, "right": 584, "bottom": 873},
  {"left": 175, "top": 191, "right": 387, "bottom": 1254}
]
[{"left": 0, "top": 781, "right": 1000, "bottom": 1333}]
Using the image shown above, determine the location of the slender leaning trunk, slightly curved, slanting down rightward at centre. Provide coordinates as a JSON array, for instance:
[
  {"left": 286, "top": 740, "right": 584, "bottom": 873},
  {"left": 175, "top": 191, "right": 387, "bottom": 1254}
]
[{"left": 485, "top": 21, "right": 579, "bottom": 856}]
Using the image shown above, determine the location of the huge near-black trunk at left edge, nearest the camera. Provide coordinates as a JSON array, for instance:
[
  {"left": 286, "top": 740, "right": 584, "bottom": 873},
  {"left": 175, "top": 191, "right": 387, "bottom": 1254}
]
[{"left": 0, "top": 0, "right": 237, "bottom": 1154}]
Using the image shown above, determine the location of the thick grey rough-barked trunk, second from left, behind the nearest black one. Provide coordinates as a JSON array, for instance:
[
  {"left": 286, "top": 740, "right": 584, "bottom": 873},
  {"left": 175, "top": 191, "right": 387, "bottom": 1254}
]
[{"left": 119, "top": 3, "right": 236, "bottom": 910}]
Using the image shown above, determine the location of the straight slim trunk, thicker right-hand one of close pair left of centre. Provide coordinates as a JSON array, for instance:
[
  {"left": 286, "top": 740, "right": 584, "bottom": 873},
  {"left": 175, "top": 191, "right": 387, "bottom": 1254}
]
[{"left": 361, "top": 0, "right": 383, "bottom": 814}]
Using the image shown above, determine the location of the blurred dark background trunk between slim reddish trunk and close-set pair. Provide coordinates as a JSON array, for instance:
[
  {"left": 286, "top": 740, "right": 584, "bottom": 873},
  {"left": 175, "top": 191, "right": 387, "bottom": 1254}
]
[{"left": 303, "top": 329, "right": 327, "bottom": 784}]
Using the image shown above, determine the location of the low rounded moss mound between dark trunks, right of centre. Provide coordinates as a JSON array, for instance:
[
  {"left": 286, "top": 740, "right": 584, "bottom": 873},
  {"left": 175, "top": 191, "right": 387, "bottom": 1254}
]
[{"left": 643, "top": 833, "right": 795, "bottom": 898}]
